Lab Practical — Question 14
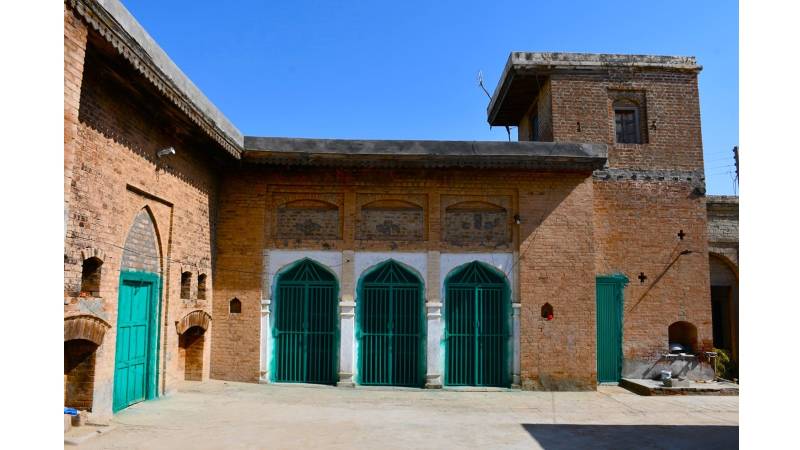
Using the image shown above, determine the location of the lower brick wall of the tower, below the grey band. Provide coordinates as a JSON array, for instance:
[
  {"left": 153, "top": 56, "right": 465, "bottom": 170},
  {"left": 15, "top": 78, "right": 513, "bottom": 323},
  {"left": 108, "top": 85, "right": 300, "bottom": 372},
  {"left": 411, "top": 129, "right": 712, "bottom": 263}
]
[{"left": 594, "top": 179, "right": 711, "bottom": 361}]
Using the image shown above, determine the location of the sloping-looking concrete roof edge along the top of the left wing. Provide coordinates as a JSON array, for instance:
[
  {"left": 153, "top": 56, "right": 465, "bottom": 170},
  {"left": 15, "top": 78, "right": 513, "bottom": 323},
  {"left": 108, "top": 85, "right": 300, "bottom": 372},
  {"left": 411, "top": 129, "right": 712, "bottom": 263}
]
[{"left": 74, "top": 0, "right": 244, "bottom": 157}]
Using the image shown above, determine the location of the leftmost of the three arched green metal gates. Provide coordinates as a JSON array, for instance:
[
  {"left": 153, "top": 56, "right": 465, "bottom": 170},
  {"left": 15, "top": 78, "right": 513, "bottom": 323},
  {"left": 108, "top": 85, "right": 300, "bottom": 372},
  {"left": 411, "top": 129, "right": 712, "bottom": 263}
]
[{"left": 273, "top": 259, "right": 339, "bottom": 384}]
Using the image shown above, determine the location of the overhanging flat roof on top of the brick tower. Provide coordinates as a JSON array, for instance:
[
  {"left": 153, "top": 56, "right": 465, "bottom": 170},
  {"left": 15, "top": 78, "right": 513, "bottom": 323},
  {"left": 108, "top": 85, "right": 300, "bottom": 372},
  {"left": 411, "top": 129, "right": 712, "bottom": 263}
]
[{"left": 487, "top": 52, "right": 703, "bottom": 126}]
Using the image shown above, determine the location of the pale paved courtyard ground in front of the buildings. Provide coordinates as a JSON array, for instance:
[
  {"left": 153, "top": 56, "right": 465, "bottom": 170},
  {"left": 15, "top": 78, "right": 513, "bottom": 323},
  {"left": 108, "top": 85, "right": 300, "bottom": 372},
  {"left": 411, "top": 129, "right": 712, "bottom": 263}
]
[{"left": 79, "top": 381, "right": 739, "bottom": 450}]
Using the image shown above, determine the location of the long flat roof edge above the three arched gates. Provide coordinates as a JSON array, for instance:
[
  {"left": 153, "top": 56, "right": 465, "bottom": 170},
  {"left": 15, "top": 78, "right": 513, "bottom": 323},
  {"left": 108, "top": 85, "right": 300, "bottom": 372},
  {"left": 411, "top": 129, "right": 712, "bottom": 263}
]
[{"left": 243, "top": 136, "right": 608, "bottom": 171}]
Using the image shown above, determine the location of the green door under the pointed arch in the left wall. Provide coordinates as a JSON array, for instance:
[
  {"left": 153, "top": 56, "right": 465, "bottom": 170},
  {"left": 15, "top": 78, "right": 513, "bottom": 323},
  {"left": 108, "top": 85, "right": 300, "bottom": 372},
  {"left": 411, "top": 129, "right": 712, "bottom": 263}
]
[{"left": 113, "top": 272, "right": 158, "bottom": 412}]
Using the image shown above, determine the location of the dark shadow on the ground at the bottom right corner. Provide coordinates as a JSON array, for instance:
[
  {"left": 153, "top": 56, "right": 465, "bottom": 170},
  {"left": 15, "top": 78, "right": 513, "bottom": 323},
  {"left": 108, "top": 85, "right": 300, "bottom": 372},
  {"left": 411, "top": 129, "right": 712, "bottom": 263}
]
[{"left": 522, "top": 423, "right": 739, "bottom": 450}]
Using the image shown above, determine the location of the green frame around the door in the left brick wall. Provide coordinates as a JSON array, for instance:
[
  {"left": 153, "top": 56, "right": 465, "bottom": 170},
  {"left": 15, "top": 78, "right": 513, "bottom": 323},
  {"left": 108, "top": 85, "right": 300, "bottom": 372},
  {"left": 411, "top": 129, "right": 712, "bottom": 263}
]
[{"left": 111, "top": 270, "right": 162, "bottom": 413}]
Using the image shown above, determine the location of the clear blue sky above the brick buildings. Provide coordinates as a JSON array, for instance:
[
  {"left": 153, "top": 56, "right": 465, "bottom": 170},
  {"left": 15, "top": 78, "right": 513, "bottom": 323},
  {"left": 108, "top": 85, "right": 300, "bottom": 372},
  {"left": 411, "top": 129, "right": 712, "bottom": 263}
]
[{"left": 122, "top": 0, "right": 739, "bottom": 194}]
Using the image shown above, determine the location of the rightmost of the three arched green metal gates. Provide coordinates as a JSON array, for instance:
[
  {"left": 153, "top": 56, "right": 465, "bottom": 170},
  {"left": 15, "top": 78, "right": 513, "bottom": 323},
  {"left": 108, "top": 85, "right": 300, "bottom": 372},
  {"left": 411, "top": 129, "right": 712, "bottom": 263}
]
[{"left": 444, "top": 261, "right": 511, "bottom": 387}]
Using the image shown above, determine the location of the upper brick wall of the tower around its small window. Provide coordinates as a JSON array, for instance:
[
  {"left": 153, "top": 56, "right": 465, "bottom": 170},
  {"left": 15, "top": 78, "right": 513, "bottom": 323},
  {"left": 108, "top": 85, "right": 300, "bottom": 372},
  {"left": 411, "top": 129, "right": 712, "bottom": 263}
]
[{"left": 551, "top": 71, "right": 703, "bottom": 170}]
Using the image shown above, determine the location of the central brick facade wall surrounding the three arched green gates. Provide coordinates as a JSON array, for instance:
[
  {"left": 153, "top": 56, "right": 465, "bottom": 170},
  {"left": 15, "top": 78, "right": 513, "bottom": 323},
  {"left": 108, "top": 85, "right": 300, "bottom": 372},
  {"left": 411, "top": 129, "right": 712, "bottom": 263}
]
[{"left": 212, "top": 167, "right": 595, "bottom": 389}]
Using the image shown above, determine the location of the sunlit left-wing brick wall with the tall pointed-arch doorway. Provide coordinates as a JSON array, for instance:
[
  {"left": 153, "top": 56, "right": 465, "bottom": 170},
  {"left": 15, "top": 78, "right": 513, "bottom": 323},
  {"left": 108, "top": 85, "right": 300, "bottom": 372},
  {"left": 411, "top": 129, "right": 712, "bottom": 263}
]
[{"left": 64, "top": 4, "right": 221, "bottom": 417}]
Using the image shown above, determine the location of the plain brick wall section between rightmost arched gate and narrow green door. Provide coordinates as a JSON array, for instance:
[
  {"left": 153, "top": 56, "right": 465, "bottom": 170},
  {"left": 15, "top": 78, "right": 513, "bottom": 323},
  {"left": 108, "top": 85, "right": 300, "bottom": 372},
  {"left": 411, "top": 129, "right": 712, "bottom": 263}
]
[{"left": 519, "top": 175, "right": 596, "bottom": 390}]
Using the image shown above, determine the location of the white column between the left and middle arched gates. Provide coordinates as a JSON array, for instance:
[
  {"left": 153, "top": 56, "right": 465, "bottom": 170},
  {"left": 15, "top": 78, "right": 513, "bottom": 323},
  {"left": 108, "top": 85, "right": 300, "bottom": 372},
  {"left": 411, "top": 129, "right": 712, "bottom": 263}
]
[{"left": 336, "top": 250, "right": 356, "bottom": 387}]
